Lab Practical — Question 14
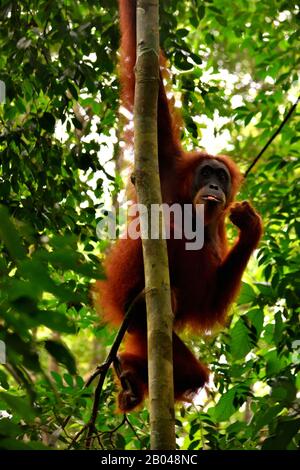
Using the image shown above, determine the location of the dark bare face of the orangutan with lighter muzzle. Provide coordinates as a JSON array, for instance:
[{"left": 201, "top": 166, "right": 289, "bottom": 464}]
[{"left": 193, "top": 160, "right": 231, "bottom": 207}]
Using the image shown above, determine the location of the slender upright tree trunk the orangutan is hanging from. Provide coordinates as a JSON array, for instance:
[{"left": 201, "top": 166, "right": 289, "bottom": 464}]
[{"left": 134, "top": 0, "right": 175, "bottom": 449}]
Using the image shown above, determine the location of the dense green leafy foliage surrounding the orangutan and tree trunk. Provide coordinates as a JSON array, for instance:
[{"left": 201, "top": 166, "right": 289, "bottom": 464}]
[{"left": 0, "top": 0, "right": 300, "bottom": 450}]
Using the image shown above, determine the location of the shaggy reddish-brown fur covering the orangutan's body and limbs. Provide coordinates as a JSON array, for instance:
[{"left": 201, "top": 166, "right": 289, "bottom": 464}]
[{"left": 95, "top": 0, "right": 262, "bottom": 411}]
